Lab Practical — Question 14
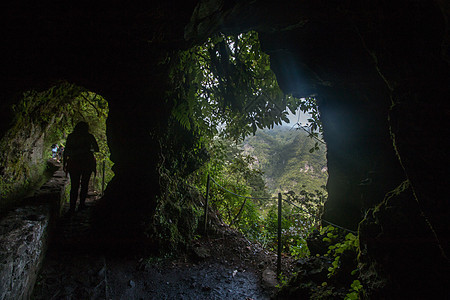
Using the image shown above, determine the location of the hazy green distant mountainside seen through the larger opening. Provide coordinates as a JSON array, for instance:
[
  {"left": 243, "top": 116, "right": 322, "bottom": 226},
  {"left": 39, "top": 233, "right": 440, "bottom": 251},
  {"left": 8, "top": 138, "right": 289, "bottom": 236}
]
[{"left": 242, "top": 126, "right": 328, "bottom": 193}]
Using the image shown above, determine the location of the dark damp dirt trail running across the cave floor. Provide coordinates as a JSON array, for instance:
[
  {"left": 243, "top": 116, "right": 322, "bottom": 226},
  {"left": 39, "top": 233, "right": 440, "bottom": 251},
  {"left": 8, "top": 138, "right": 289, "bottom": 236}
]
[{"left": 32, "top": 176, "right": 289, "bottom": 300}]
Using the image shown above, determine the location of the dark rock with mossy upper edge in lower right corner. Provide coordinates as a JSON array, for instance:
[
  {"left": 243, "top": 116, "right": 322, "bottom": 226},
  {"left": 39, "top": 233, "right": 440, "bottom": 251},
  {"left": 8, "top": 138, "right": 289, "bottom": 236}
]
[{"left": 359, "top": 181, "right": 450, "bottom": 299}]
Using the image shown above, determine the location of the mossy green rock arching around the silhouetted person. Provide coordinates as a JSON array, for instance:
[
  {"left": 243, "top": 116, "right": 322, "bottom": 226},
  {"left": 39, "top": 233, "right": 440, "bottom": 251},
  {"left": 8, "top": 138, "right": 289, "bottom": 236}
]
[{"left": 0, "top": 82, "right": 114, "bottom": 214}]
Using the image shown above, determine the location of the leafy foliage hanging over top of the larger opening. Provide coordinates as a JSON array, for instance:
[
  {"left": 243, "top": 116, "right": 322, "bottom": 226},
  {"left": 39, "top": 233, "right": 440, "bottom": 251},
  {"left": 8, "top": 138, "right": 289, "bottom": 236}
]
[{"left": 168, "top": 31, "right": 310, "bottom": 140}]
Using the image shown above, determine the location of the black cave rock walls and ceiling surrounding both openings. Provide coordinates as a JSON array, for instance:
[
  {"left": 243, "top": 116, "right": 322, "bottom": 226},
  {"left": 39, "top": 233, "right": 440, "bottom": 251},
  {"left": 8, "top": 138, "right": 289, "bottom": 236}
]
[{"left": 0, "top": 0, "right": 450, "bottom": 299}]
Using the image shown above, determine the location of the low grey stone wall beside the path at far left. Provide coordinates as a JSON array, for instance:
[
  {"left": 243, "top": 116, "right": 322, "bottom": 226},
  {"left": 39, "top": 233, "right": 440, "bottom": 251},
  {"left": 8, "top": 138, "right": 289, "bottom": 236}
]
[{"left": 0, "top": 170, "right": 67, "bottom": 300}]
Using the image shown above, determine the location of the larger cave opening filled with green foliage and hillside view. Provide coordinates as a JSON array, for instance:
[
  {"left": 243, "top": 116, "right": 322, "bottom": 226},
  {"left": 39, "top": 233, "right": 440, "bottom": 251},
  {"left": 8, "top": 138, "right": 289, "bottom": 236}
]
[{"left": 166, "top": 31, "right": 328, "bottom": 257}]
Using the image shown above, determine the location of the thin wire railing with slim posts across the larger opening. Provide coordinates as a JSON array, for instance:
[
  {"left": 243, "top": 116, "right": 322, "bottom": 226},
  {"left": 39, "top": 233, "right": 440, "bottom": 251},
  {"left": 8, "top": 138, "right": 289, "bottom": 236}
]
[{"left": 204, "top": 174, "right": 358, "bottom": 275}]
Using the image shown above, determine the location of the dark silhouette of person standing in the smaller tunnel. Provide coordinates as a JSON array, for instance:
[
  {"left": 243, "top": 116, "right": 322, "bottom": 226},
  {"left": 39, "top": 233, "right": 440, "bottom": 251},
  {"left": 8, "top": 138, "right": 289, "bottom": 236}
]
[{"left": 63, "top": 122, "right": 99, "bottom": 214}]
